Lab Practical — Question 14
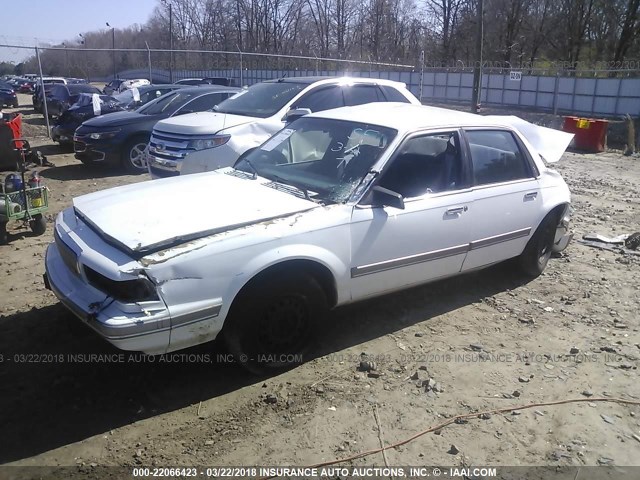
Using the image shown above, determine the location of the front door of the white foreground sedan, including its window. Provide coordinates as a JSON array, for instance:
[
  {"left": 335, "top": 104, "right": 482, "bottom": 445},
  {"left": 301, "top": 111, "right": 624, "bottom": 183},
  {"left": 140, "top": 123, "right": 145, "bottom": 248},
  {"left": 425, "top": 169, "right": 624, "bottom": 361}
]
[{"left": 351, "top": 127, "right": 473, "bottom": 300}]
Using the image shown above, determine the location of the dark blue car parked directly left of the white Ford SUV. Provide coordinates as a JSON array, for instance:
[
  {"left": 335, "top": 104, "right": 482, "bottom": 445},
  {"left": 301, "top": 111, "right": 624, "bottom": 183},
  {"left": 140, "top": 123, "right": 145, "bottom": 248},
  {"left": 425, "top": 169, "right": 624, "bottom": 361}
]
[{"left": 73, "top": 85, "right": 238, "bottom": 173}]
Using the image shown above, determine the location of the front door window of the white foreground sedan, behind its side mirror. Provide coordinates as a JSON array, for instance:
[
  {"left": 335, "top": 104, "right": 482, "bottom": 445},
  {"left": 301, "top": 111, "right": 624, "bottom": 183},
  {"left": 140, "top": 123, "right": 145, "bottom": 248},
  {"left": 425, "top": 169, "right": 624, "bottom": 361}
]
[{"left": 380, "top": 132, "right": 463, "bottom": 198}]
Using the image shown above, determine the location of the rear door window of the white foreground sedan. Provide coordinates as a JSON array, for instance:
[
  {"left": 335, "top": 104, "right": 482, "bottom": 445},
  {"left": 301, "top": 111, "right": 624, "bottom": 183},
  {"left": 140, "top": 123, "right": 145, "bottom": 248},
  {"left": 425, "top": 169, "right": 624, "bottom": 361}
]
[{"left": 466, "top": 130, "right": 533, "bottom": 185}]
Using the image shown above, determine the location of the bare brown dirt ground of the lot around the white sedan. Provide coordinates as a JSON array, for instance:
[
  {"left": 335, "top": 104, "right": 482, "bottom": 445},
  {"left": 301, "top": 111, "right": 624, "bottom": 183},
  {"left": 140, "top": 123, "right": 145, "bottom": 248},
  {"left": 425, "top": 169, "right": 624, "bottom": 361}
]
[{"left": 0, "top": 95, "right": 640, "bottom": 472}]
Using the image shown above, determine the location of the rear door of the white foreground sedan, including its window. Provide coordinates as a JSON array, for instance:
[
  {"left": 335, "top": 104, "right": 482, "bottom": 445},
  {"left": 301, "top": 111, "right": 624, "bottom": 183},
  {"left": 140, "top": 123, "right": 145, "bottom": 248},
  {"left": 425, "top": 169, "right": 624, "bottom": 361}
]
[{"left": 463, "top": 128, "right": 542, "bottom": 270}]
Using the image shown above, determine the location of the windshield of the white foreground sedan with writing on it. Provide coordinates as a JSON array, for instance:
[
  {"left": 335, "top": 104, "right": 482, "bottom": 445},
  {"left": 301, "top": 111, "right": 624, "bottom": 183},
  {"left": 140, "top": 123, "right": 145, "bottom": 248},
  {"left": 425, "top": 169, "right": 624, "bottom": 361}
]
[{"left": 235, "top": 118, "right": 397, "bottom": 203}]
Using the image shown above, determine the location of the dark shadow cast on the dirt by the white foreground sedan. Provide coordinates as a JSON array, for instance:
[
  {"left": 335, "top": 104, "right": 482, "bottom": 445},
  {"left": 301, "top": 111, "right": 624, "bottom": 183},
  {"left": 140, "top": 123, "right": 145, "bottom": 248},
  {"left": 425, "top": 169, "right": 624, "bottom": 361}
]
[{"left": 0, "top": 264, "right": 526, "bottom": 463}]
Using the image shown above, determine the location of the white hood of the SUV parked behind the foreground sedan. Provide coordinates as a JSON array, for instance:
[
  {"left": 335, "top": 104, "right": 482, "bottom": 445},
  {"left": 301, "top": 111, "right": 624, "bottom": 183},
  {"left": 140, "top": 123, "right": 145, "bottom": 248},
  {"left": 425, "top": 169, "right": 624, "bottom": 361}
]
[{"left": 154, "top": 112, "right": 256, "bottom": 135}]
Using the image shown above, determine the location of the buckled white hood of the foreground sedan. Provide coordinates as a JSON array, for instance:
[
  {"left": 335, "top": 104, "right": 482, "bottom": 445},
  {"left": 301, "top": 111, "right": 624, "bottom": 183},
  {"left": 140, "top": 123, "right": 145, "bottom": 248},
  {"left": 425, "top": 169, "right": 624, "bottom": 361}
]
[{"left": 73, "top": 172, "right": 318, "bottom": 257}]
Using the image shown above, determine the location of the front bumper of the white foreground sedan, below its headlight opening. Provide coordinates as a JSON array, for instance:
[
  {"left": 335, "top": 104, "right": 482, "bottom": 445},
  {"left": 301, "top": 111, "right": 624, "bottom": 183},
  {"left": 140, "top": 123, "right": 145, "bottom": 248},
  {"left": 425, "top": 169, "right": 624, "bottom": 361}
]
[{"left": 45, "top": 239, "right": 171, "bottom": 355}]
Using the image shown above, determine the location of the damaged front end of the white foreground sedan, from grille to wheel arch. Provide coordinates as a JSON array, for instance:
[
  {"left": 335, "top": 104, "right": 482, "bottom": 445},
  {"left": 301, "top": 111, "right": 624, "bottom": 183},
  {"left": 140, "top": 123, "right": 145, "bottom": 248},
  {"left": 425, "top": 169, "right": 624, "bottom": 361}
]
[{"left": 44, "top": 209, "right": 228, "bottom": 355}]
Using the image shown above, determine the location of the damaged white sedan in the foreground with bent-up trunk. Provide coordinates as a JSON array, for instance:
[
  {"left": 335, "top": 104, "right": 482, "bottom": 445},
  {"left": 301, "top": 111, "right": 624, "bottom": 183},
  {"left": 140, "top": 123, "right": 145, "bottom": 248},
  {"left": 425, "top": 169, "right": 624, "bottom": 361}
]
[{"left": 46, "top": 103, "right": 572, "bottom": 369}]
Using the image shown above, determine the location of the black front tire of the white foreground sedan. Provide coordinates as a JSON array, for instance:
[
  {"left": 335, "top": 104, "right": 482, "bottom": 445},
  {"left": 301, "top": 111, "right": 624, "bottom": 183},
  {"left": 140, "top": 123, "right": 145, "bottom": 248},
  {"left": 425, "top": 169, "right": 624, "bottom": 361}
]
[{"left": 223, "top": 272, "right": 328, "bottom": 375}]
